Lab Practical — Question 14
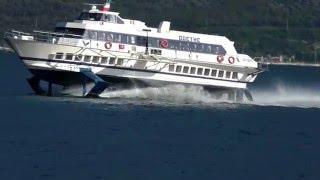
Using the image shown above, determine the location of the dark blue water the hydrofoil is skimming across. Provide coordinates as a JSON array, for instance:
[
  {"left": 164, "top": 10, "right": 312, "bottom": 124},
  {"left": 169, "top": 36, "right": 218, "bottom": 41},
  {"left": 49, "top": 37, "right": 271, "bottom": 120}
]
[{"left": 0, "top": 53, "right": 320, "bottom": 180}]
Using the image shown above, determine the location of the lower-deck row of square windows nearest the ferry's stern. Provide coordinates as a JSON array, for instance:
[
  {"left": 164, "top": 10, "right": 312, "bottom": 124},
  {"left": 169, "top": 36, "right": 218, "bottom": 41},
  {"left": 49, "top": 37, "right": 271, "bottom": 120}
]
[{"left": 169, "top": 65, "right": 238, "bottom": 79}]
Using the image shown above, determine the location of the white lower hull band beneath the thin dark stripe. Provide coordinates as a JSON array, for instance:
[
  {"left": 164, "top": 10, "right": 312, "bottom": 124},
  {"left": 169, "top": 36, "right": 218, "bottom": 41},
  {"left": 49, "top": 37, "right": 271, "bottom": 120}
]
[{"left": 23, "top": 59, "right": 246, "bottom": 89}]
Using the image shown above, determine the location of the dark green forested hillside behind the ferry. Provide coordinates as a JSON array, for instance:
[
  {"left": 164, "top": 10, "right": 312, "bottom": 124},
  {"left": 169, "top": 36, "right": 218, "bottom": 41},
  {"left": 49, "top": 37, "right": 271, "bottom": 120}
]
[{"left": 0, "top": 0, "right": 320, "bottom": 61}]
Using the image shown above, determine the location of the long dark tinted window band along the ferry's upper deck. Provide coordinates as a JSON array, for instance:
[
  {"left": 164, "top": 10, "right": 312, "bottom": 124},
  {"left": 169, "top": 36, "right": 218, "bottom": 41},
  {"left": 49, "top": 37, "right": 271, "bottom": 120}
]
[{"left": 56, "top": 27, "right": 226, "bottom": 55}]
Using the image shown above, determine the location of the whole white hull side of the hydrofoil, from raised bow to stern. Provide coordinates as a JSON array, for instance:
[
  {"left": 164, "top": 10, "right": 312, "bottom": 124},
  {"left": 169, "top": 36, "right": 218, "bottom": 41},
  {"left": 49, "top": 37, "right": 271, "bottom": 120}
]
[{"left": 9, "top": 39, "right": 256, "bottom": 89}]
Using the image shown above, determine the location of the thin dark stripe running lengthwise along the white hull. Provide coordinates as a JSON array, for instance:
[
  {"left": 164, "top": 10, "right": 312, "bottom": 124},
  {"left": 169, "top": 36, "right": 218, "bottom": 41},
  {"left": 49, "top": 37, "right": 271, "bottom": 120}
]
[{"left": 20, "top": 57, "right": 248, "bottom": 83}]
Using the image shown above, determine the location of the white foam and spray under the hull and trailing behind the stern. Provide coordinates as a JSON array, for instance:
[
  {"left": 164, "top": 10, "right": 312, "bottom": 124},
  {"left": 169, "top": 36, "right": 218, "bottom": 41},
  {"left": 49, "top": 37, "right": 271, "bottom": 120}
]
[{"left": 57, "top": 82, "right": 320, "bottom": 108}]
